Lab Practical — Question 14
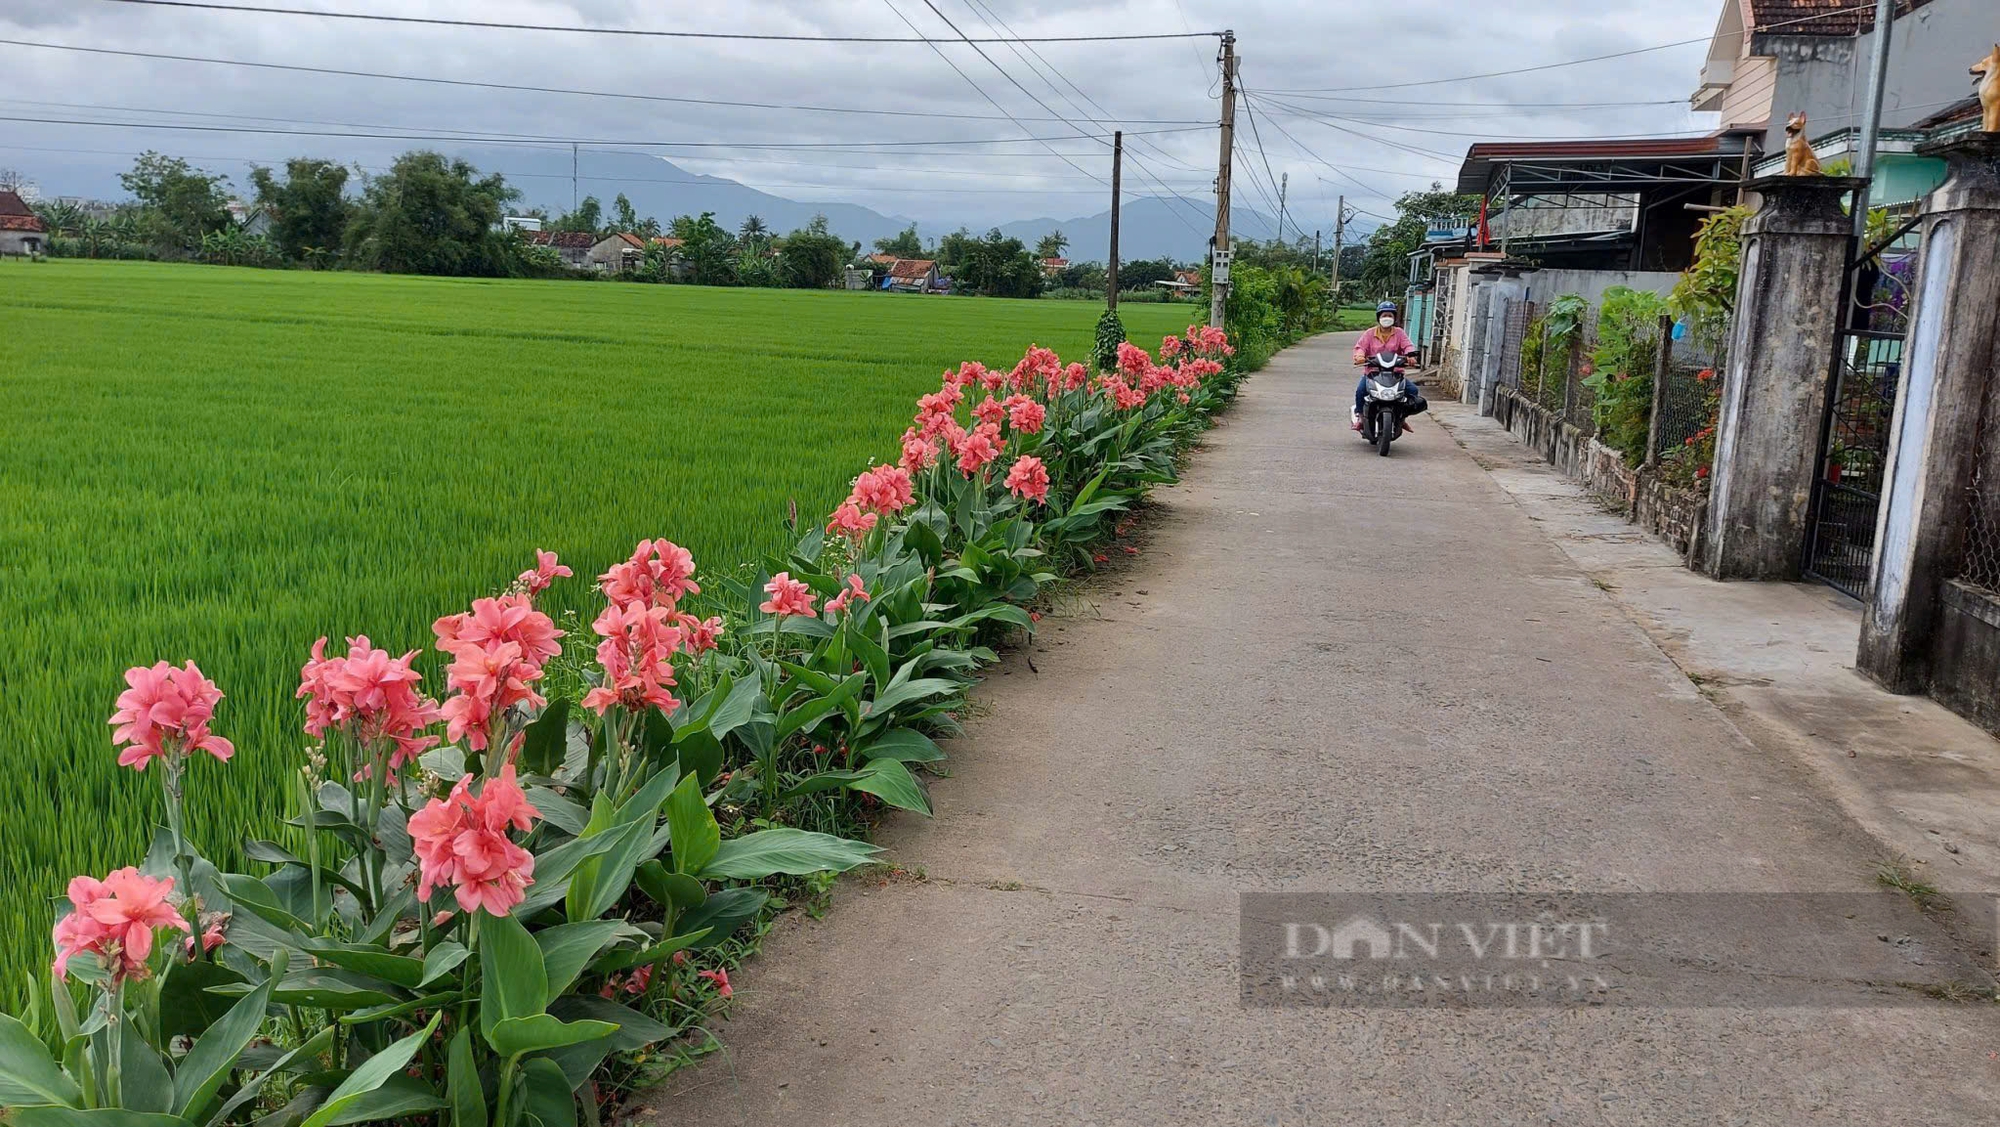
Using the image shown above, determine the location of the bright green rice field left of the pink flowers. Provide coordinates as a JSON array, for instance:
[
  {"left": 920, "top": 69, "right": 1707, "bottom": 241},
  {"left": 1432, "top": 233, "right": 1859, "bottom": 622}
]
[{"left": 0, "top": 260, "right": 1194, "bottom": 1009}]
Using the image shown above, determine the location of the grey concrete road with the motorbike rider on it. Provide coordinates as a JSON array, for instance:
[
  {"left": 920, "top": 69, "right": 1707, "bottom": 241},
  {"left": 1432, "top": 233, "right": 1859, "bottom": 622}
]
[{"left": 636, "top": 336, "right": 2000, "bottom": 1127}]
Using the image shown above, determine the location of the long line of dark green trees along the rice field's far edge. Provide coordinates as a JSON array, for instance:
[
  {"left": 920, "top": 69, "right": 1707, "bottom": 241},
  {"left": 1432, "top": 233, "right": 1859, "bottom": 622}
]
[{"left": 27, "top": 150, "right": 1200, "bottom": 298}]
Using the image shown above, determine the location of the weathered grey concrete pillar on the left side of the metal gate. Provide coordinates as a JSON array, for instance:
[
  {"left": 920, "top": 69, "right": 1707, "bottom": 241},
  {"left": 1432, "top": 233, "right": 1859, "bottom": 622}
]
[{"left": 1702, "top": 176, "right": 1868, "bottom": 579}]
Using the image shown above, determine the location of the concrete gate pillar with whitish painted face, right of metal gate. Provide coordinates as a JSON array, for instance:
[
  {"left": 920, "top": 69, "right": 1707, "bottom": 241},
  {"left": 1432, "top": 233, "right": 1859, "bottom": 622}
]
[{"left": 1856, "top": 134, "right": 2000, "bottom": 693}]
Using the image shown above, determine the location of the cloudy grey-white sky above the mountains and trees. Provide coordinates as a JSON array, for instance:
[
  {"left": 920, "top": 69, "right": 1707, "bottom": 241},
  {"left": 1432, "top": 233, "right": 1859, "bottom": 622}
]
[{"left": 0, "top": 0, "right": 1720, "bottom": 234}]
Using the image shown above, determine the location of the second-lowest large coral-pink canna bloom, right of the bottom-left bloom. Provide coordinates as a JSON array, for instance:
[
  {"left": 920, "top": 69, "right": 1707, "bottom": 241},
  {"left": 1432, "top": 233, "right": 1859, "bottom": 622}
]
[{"left": 410, "top": 763, "right": 542, "bottom": 915}]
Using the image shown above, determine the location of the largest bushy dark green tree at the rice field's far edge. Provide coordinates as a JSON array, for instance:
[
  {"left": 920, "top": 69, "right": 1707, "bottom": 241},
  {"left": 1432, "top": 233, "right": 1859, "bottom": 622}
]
[{"left": 346, "top": 150, "right": 528, "bottom": 278}]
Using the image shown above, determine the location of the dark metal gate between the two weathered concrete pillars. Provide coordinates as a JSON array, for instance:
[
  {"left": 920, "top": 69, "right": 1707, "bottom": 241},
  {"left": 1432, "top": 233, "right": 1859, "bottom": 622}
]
[{"left": 1802, "top": 218, "right": 1920, "bottom": 599}]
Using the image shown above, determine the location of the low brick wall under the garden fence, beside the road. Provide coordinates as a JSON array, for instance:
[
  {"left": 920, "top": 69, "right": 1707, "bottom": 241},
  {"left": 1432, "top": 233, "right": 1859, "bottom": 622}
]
[{"left": 1494, "top": 388, "right": 1708, "bottom": 560}]
